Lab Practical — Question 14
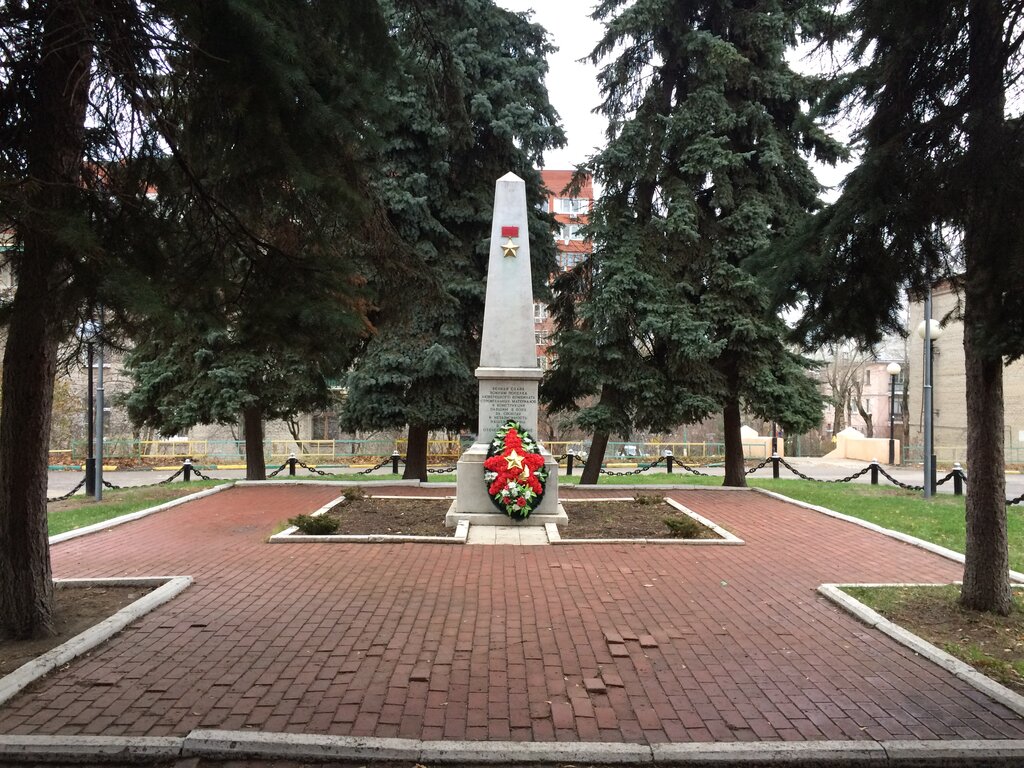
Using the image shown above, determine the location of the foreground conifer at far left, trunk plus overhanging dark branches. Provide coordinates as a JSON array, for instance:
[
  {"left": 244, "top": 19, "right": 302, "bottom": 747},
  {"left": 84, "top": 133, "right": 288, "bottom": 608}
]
[{"left": 0, "top": 0, "right": 384, "bottom": 637}]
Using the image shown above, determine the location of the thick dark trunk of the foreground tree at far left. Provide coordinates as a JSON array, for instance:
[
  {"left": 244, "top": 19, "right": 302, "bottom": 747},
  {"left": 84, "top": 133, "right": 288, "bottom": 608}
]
[{"left": 0, "top": 0, "right": 92, "bottom": 639}]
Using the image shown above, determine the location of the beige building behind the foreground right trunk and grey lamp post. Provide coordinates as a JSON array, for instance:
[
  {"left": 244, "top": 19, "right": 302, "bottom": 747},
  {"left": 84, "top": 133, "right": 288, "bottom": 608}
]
[{"left": 907, "top": 285, "right": 1024, "bottom": 464}]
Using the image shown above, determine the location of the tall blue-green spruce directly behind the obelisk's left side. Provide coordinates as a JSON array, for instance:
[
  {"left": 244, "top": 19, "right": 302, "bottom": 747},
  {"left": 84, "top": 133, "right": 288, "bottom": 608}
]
[{"left": 343, "top": 0, "right": 564, "bottom": 480}]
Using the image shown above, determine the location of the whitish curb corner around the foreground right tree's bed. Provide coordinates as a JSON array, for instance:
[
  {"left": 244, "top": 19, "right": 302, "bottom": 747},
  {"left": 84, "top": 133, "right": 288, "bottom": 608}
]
[{"left": 818, "top": 584, "right": 1024, "bottom": 720}]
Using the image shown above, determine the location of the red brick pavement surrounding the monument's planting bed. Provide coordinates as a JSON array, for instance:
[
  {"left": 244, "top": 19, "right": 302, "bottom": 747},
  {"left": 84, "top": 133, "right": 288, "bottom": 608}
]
[{"left": 0, "top": 486, "right": 1024, "bottom": 742}]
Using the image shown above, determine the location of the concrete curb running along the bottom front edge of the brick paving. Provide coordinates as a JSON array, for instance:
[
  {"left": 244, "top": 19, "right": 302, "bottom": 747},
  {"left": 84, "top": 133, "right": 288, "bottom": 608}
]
[{"left": 6, "top": 729, "right": 1024, "bottom": 767}]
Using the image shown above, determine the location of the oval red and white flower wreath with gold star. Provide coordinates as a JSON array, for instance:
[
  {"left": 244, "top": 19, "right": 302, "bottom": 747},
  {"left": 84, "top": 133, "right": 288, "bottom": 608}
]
[{"left": 483, "top": 421, "right": 548, "bottom": 520}]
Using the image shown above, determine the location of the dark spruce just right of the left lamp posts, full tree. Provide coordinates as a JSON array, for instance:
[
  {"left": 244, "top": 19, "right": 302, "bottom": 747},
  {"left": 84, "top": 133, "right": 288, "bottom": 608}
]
[{"left": 120, "top": 3, "right": 387, "bottom": 479}]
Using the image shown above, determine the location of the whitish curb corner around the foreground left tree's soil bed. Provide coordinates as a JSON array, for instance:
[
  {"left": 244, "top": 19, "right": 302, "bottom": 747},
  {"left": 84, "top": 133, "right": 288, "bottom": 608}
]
[{"left": 0, "top": 577, "right": 193, "bottom": 705}]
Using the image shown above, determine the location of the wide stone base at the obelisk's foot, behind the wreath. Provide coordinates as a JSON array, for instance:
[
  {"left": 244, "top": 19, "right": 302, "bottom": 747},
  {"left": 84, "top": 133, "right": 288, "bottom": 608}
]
[{"left": 444, "top": 442, "right": 569, "bottom": 528}]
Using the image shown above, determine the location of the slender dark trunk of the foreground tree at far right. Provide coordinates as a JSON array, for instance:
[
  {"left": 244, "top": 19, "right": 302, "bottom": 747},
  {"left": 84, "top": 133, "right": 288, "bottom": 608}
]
[{"left": 961, "top": 0, "right": 1017, "bottom": 615}]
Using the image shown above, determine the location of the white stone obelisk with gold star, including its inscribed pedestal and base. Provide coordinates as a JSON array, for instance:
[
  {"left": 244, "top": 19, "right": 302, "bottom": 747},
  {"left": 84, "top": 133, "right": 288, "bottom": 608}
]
[{"left": 445, "top": 173, "right": 567, "bottom": 526}]
